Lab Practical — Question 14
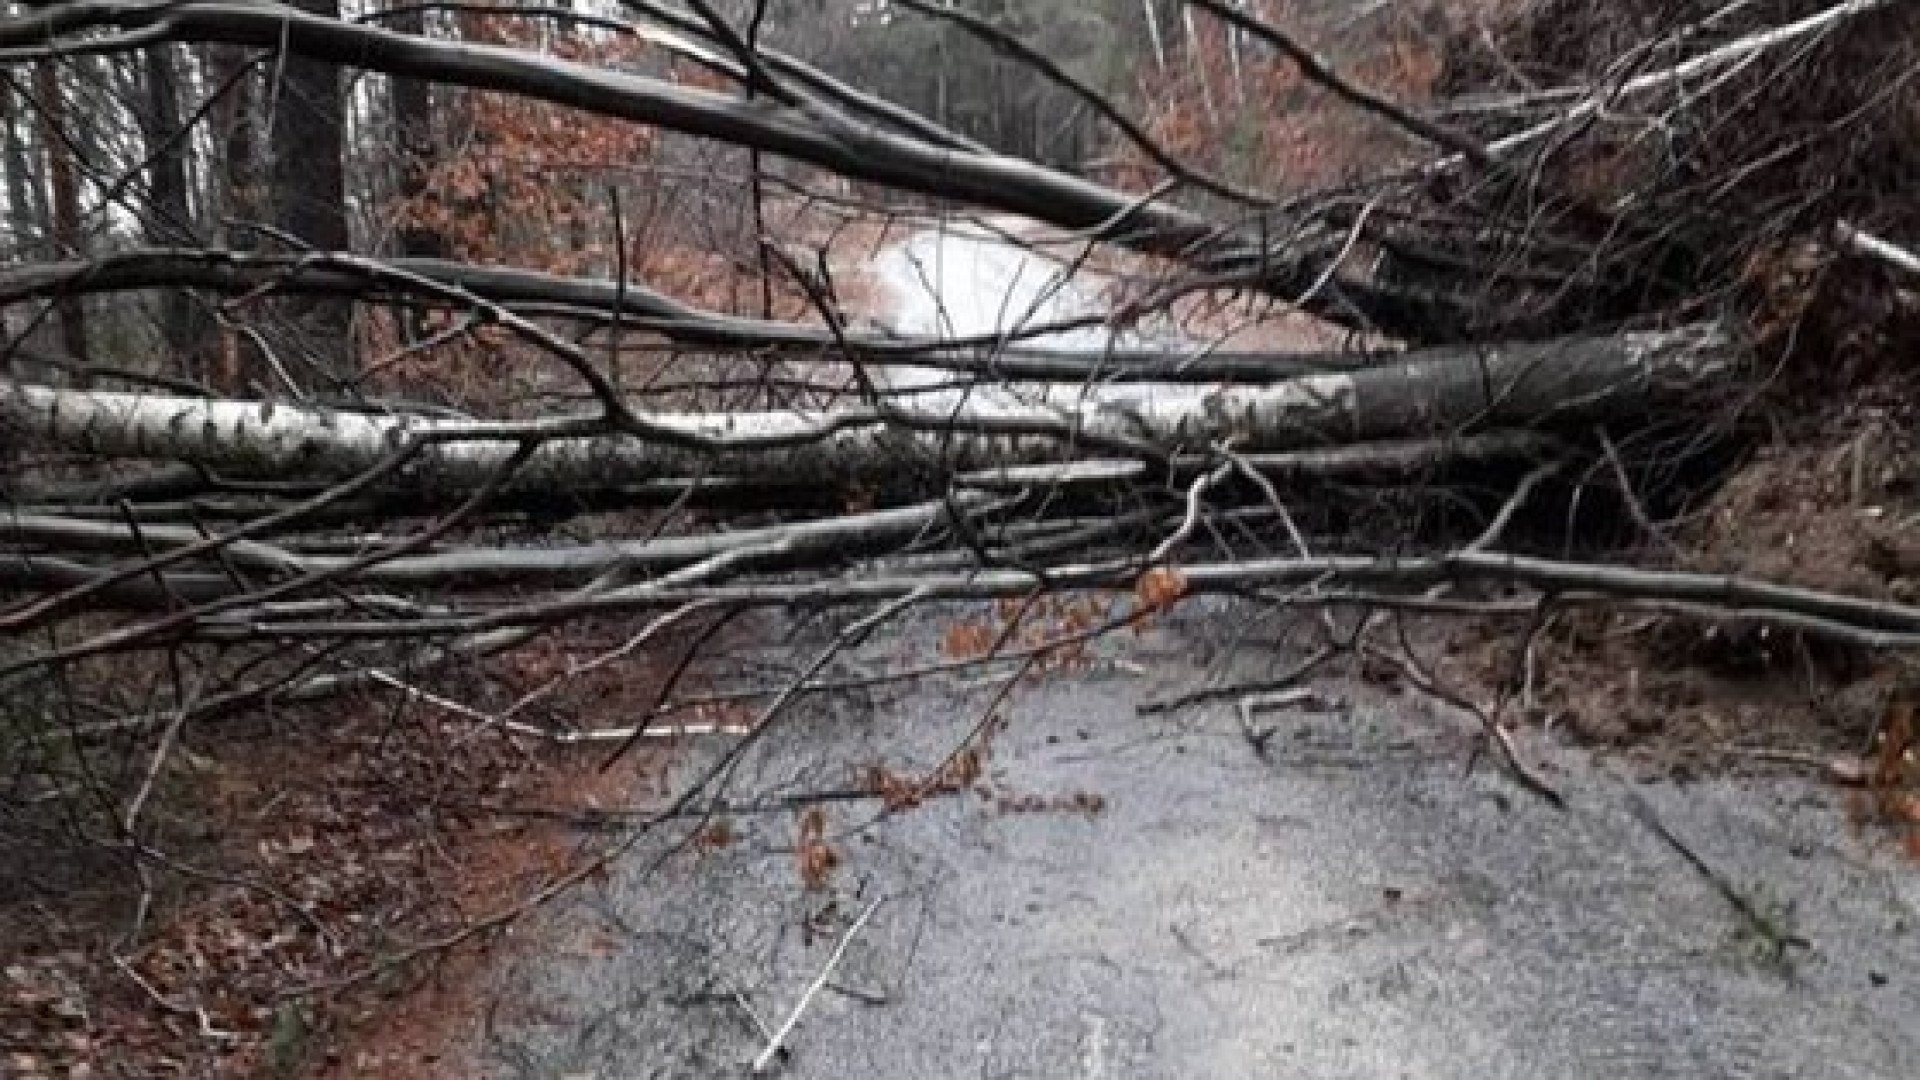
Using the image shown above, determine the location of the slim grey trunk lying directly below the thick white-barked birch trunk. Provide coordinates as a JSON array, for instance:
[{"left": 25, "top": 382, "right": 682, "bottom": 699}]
[{"left": 0, "top": 432, "right": 1569, "bottom": 595}]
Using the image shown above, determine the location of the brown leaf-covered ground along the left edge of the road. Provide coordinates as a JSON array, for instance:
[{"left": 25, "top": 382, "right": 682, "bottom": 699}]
[{"left": 0, "top": 625, "right": 720, "bottom": 1076}]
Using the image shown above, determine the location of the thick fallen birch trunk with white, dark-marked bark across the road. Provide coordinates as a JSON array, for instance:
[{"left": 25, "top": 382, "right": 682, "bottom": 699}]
[{"left": 0, "top": 325, "right": 1740, "bottom": 490}]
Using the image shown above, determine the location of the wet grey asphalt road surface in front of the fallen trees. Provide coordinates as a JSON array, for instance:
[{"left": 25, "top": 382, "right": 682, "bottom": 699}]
[{"left": 484, "top": 613, "right": 1920, "bottom": 1078}]
